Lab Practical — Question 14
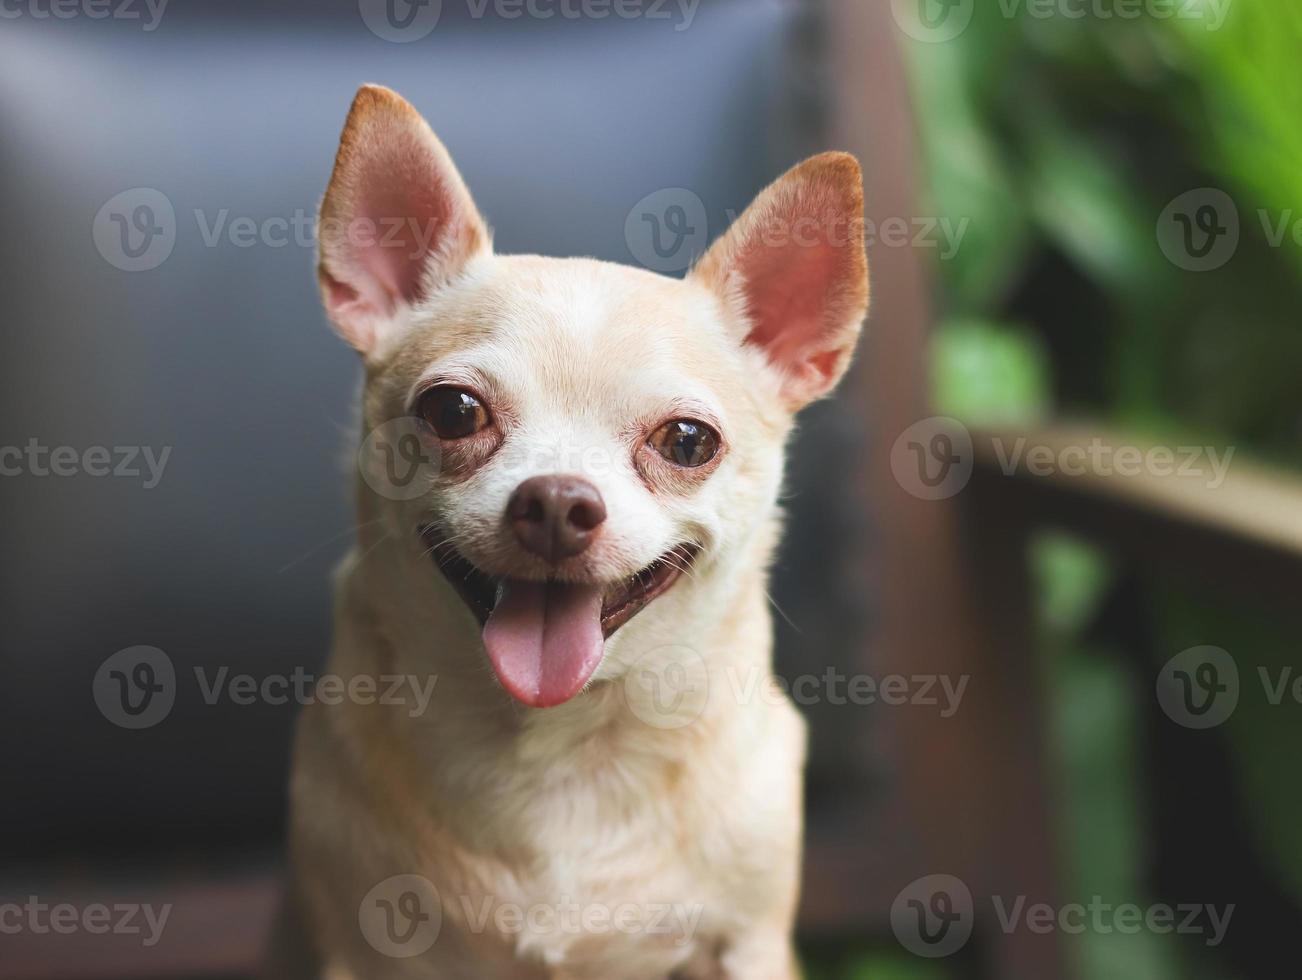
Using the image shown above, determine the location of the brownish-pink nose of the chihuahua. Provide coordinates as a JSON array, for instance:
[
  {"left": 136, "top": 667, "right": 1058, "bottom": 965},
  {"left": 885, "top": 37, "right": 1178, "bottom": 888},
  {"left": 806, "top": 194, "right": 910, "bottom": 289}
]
[{"left": 506, "top": 476, "right": 605, "bottom": 562}]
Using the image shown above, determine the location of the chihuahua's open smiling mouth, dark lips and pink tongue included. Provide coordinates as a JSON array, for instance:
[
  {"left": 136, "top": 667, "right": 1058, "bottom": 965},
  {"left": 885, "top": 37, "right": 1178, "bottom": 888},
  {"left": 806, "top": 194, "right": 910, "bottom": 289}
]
[{"left": 421, "top": 527, "right": 699, "bottom": 708}]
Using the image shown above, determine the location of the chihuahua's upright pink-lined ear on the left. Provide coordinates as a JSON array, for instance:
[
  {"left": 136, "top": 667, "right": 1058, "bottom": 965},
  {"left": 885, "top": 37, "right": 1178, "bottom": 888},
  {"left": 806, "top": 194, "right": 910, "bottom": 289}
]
[{"left": 318, "top": 85, "right": 491, "bottom": 354}]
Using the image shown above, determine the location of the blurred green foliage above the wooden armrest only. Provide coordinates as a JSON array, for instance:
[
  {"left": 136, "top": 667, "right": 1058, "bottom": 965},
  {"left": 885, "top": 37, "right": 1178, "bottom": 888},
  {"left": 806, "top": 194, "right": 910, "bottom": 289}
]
[{"left": 906, "top": 0, "right": 1302, "bottom": 465}]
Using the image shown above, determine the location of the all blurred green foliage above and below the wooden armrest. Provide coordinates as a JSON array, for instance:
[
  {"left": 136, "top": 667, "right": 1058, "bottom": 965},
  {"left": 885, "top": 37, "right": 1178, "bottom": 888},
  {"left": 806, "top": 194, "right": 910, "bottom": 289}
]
[{"left": 807, "top": 0, "right": 1302, "bottom": 980}]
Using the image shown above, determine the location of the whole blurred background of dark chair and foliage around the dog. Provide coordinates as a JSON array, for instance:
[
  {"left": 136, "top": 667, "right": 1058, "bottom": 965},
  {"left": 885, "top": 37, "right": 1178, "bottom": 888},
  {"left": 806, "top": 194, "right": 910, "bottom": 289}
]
[{"left": 0, "top": 0, "right": 1302, "bottom": 980}]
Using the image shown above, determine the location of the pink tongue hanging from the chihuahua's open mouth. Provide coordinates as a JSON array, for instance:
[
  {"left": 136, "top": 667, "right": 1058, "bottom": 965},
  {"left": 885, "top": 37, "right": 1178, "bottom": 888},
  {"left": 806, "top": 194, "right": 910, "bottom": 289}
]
[{"left": 484, "top": 579, "right": 604, "bottom": 708}]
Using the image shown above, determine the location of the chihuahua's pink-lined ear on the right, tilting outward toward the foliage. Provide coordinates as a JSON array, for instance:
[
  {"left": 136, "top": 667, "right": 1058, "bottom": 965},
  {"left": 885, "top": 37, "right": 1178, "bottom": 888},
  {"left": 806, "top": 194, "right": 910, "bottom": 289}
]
[{"left": 691, "top": 154, "right": 868, "bottom": 411}]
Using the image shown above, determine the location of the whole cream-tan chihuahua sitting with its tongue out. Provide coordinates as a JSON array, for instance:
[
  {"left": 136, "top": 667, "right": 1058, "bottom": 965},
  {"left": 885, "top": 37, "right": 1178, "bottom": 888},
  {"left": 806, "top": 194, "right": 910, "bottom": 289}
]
[{"left": 277, "top": 86, "right": 868, "bottom": 980}]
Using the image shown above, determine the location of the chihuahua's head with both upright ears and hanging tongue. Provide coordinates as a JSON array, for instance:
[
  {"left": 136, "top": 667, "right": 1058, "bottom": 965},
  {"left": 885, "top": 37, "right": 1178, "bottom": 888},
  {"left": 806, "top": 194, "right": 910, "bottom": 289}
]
[{"left": 319, "top": 86, "right": 867, "bottom": 707}]
